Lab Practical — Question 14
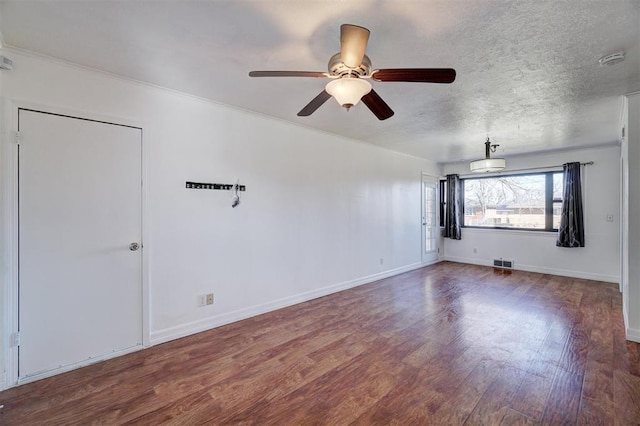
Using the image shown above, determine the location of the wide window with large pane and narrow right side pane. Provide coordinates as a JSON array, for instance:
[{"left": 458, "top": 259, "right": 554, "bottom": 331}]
[{"left": 462, "top": 172, "right": 562, "bottom": 231}]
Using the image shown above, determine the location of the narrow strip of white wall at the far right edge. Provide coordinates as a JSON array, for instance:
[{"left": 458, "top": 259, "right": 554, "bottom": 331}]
[{"left": 621, "top": 93, "right": 640, "bottom": 342}]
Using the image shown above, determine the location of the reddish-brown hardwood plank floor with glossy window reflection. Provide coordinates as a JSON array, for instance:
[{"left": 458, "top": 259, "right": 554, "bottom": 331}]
[{"left": 0, "top": 262, "right": 640, "bottom": 425}]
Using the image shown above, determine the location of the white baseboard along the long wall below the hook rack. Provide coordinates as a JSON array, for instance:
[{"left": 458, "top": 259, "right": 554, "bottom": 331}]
[{"left": 150, "top": 263, "right": 425, "bottom": 345}]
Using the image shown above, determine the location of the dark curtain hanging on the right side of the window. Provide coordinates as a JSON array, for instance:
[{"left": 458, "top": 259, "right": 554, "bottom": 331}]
[{"left": 556, "top": 163, "right": 584, "bottom": 247}]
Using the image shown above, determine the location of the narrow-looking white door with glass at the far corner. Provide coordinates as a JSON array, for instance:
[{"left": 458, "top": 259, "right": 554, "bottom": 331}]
[{"left": 422, "top": 175, "right": 438, "bottom": 263}]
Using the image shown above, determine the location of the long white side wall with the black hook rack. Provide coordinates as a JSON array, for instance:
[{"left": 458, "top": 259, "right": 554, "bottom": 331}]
[{"left": 0, "top": 50, "right": 440, "bottom": 388}]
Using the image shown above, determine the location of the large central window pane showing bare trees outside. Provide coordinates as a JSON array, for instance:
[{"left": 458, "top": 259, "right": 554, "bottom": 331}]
[{"left": 464, "top": 174, "right": 545, "bottom": 229}]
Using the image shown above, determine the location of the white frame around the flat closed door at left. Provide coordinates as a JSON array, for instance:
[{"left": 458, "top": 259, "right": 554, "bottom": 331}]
[{"left": 0, "top": 100, "right": 150, "bottom": 390}]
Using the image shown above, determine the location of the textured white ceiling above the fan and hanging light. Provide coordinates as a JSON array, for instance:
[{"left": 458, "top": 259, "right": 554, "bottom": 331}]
[{"left": 0, "top": 0, "right": 640, "bottom": 161}]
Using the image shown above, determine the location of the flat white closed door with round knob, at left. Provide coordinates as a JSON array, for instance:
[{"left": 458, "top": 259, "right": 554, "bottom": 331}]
[{"left": 18, "top": 109, "right": 142, "bottom": 379}]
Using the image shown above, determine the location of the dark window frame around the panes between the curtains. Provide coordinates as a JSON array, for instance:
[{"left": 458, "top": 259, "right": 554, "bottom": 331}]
[{"left": 440, "top": 170, "right": 563, "bottom": 232}]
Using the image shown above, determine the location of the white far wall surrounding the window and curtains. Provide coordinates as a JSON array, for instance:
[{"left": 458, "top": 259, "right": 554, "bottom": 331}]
[{"left": 444, "top": 146, "right": 620, "bottom": 283}]
